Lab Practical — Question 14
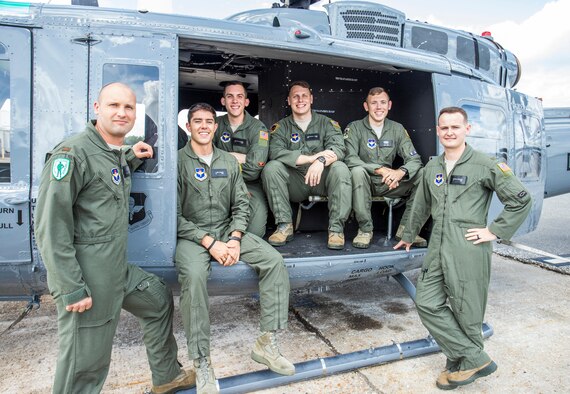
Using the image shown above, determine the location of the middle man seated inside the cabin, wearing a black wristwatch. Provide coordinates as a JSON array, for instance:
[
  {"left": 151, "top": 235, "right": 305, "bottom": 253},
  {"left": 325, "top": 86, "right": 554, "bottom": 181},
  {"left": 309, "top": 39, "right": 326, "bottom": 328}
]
[{"left": 261, "top": 81, "right": 352, "bottom": 249}]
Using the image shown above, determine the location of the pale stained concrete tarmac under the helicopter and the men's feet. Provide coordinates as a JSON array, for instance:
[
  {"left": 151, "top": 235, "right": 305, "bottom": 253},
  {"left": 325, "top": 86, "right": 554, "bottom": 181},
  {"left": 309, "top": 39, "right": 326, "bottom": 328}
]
[{"left": 0, "top": 196, "right": 570, "bottom": 394}]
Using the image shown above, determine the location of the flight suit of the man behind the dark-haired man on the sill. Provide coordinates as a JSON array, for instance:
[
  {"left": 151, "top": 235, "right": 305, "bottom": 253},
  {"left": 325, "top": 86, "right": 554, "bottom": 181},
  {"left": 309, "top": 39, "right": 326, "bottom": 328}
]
[{"left": 214, "top": 111, "right": 269, "bottom": 237}]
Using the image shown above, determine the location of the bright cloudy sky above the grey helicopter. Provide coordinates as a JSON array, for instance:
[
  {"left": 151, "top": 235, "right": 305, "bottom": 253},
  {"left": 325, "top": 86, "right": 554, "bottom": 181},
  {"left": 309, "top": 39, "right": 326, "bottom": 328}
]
[{"left": 8, "top": 0, "right": 570, "bottom": 107}]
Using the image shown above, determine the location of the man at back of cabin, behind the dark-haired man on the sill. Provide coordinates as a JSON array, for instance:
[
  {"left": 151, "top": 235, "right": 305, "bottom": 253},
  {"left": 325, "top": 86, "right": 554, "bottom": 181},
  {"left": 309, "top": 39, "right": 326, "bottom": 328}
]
[{"left": 214, "top": 81, "right": 269, "bottom": 237}]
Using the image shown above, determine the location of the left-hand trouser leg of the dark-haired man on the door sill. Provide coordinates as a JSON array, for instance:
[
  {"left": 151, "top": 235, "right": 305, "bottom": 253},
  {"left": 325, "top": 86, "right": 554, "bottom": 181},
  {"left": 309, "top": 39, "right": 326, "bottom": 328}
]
[{"left": 175, "top": 239, "right": 211, "bottom": 360}]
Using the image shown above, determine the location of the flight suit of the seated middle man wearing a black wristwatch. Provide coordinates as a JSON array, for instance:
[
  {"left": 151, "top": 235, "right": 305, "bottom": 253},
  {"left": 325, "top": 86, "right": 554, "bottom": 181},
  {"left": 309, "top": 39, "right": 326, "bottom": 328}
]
[{"left": 261, "top": 111, "right": 352, "bottom": 233}]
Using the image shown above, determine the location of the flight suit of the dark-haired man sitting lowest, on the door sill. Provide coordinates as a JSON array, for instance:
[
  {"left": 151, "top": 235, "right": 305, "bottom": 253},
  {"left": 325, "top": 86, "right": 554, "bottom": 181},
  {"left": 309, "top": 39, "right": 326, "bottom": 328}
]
[{"left": 175, "top": 143, "right": 290, "bottom": 359}]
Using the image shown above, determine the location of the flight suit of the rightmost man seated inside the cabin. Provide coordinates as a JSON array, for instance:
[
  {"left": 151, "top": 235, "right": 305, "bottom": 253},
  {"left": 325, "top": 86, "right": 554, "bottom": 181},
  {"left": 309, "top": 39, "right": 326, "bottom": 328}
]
[{"left": 344, "top": 116, "right": 422, "bottom": 232}]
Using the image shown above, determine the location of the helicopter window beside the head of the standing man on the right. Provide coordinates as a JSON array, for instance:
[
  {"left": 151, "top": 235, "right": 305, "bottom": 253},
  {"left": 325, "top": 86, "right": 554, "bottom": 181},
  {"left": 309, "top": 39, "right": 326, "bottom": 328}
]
[{"left": 462, "top": 104, "right": 508, "bottom": 162}]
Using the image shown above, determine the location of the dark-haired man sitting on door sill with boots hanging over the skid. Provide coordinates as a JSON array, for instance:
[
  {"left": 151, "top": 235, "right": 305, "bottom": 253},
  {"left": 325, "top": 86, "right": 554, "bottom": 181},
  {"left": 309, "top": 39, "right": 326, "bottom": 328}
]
[{"left": 176, "top": 103, "right": 295, "bottom": 394}]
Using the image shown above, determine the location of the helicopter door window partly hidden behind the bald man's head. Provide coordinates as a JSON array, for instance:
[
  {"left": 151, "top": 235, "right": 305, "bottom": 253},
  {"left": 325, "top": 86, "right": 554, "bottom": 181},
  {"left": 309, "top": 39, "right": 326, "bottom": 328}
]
[{"left": 103, "top": 63, "right": 159, "bottom": 173}]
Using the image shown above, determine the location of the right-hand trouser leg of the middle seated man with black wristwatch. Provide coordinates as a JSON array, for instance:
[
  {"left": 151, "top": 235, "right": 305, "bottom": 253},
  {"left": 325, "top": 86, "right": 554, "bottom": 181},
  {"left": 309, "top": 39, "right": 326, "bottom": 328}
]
[{"left": 321, "top": 161, "right": 352, "bottom": 233}]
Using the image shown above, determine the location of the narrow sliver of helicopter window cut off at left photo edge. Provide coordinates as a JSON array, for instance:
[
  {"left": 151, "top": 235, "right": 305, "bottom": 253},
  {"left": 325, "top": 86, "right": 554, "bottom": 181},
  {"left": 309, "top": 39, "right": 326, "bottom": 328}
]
[{"left": 0, "top": 59, "right": 10, "bottom": 183}]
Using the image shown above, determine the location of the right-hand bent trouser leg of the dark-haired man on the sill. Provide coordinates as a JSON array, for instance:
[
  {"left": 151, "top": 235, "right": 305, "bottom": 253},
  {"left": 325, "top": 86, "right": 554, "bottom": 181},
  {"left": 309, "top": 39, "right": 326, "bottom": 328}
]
[{"left": 240, "top": 234, "right": 290, "bottom": 331}]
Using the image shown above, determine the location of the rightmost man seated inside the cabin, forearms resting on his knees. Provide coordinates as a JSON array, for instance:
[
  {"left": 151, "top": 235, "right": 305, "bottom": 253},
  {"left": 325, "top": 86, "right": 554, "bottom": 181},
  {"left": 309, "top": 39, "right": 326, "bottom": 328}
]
[{"left": 344, "top": 87, "right": 427, "bottom": 248}]
